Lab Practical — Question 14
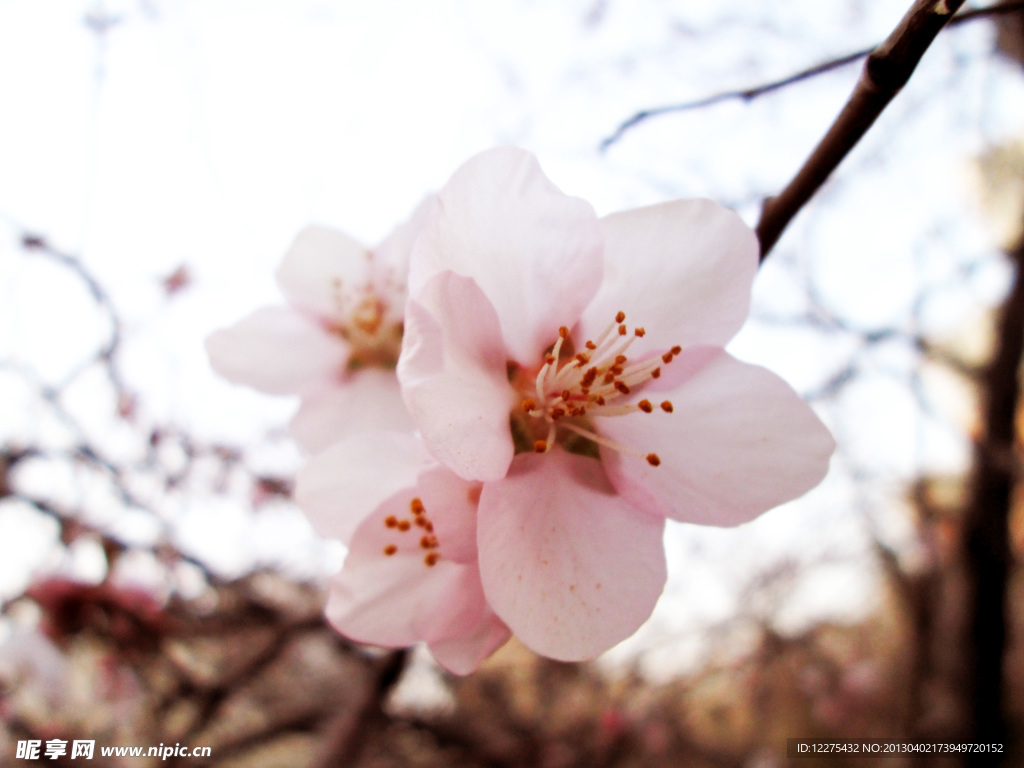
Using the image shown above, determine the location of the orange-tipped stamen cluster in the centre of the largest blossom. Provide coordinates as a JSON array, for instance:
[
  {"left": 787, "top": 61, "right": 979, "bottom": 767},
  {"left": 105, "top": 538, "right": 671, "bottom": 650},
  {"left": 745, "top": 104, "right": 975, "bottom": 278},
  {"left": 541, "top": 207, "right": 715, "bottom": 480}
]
[{"left": 510, "top": 312, "right": 682, "bottom": 467}]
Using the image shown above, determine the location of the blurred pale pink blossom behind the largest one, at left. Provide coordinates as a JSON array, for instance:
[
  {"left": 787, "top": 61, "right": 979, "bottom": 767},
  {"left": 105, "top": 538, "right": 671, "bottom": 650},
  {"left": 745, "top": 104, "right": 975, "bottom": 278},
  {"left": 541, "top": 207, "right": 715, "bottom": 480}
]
[{"left": 207, "top": 197, "right": 435, "bottom": 453}]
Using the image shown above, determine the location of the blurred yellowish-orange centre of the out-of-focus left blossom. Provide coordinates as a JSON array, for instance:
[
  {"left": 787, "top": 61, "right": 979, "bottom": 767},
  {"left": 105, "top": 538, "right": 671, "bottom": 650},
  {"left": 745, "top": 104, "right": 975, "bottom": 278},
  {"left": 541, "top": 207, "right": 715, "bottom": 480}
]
[{"left": 327, "top": 275, "right": 406, "bottom": 371}]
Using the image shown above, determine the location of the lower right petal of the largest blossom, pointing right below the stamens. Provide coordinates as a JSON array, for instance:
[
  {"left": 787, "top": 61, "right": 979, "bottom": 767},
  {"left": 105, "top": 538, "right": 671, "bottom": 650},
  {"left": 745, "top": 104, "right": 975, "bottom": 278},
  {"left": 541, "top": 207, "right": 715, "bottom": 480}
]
[{"left": 595, "top": 349, "right": 836, "bottom": 526}]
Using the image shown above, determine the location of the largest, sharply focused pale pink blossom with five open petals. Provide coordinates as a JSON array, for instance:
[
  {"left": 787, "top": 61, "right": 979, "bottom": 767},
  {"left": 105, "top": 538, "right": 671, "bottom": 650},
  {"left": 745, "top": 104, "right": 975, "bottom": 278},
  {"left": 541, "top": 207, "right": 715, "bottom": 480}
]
[{"left": 397, "top": 147, "right": 835, "bottom": 659}]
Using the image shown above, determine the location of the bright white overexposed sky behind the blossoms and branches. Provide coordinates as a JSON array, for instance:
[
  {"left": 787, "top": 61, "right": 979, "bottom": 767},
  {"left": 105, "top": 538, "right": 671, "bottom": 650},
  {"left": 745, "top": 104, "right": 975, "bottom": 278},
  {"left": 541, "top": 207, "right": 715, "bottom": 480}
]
[{"left": 0, "top": 0, "right": 1024, "bottom": 671}]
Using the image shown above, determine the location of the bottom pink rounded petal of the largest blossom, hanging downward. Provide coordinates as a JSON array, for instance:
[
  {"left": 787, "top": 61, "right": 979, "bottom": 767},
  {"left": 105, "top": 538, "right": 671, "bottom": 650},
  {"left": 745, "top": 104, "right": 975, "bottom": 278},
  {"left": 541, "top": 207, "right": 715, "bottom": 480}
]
[{"left": 477, "top": 449, "right": 666, "bottom": 660}]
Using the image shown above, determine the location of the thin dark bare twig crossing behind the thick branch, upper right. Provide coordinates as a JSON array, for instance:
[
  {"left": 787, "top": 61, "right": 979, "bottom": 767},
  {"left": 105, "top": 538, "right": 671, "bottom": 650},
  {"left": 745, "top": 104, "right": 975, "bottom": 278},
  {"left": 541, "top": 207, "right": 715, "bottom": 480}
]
[{"left": 600, "top": 0, "right": 1024, "bottom": 152}]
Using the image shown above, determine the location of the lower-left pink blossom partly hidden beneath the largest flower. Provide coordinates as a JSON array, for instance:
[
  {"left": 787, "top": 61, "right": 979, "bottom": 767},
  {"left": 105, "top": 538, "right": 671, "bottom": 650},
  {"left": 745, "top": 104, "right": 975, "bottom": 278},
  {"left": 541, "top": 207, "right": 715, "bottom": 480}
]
[{"left": 295, "top": 432, "right": 511, "bottom": 675}]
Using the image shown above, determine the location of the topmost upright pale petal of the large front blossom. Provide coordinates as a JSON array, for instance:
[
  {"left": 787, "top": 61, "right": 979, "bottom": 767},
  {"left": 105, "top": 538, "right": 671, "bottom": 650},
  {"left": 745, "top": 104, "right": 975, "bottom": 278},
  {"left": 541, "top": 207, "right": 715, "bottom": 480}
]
[{"left": 410, "top": 146, "right": 601, "bottom": 365}]
